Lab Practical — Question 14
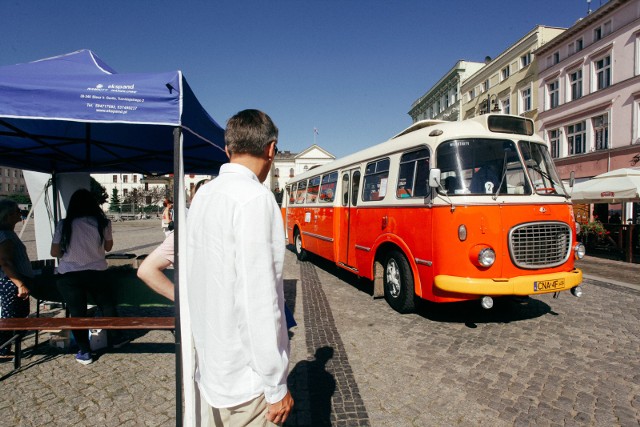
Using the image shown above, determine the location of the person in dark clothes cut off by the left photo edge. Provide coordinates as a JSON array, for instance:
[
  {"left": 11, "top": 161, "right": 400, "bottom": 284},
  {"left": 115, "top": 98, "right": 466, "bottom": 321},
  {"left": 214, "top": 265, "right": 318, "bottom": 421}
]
[{"left": 0, "top": 199, "right": 34, "bottom": 361}]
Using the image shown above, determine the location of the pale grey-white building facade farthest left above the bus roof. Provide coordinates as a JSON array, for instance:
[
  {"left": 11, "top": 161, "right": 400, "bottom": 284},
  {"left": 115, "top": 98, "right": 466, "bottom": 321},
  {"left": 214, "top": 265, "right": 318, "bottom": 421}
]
[{"left": 408, "top": 60, "right": 485, "bottom": 123}]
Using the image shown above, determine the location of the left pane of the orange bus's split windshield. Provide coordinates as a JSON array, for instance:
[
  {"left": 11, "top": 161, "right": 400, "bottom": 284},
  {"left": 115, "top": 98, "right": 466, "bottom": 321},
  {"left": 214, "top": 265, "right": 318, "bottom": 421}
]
[{"left": 436, "top": 138, "right": 531, "bottom": 196}]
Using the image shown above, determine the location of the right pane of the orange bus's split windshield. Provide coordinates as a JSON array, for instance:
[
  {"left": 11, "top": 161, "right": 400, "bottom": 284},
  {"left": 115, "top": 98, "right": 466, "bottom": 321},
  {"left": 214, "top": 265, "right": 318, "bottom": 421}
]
[{"left": 518, "top": 141, "right": 567, "bottom": 197}]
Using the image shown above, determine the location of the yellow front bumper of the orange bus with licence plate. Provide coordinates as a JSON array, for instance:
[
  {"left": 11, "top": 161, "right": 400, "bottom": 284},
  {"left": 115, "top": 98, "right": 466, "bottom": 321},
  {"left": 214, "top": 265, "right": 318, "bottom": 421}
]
[{"left": 434, "top": 268, "right": 582, "bottom": 296}]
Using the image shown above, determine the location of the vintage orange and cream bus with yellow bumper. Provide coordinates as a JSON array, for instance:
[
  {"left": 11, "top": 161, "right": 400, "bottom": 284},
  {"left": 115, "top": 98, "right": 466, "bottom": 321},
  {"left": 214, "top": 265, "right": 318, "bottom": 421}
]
[{"left": 283, "top": 114, "right": 584, "bottom": 313}]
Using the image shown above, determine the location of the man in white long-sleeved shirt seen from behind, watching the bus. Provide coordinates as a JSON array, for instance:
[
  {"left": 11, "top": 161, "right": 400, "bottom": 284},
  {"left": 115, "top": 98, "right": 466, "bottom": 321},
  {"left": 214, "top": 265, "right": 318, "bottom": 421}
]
[{"left": 185, "top": 110, "right": 293, "bottom": 426}]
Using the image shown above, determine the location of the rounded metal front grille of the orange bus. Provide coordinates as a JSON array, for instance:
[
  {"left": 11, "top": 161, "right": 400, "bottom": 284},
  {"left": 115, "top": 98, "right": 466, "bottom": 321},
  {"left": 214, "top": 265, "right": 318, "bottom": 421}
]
[{"left": 509, "top": 222, "right": 571, "bottom": 269}]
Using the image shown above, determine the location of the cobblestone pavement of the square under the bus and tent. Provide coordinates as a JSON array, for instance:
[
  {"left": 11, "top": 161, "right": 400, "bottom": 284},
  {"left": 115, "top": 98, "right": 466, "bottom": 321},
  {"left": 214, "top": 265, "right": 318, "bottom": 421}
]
[{"left": 0, "top": 220, "right": 640, "bottom": 427}]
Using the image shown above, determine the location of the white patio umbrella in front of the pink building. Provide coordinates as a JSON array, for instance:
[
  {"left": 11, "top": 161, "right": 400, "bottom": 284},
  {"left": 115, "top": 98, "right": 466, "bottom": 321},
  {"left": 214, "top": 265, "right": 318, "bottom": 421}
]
[{"left": 571, "top": 168, "right": 640, "bottom": 203}]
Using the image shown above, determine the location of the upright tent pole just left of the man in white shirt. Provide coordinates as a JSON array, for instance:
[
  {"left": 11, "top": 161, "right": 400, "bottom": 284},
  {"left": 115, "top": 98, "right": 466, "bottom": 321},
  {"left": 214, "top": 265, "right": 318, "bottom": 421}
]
[{"left": 173, "top": 127, "right": 186, "bottom": 427}]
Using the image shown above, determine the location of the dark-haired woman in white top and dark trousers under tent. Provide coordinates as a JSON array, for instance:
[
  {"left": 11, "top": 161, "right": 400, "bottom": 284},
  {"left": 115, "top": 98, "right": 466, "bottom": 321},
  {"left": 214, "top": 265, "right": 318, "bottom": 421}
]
[{"left": 51, "top": 189, "right": 124, "bottom": 365}]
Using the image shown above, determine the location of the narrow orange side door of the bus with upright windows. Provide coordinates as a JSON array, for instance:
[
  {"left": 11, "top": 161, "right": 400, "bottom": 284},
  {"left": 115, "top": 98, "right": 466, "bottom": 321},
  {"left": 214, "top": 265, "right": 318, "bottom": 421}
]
[{"left": 336, "top": 169, "right": 360, "bottom": 267}]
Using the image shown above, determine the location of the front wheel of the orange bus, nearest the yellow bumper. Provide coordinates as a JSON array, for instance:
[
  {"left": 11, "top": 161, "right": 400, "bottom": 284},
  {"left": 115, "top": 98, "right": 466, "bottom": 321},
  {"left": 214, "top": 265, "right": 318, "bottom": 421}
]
[{"left": 384, "top": 251, "right": 415, "bottom": 313}]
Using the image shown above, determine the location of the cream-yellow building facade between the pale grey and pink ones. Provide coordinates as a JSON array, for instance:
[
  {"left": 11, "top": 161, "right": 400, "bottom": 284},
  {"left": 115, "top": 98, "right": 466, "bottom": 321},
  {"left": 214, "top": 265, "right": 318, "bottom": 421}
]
[{"left": 461, "top": 25, "right": 565, "bottom": 121}]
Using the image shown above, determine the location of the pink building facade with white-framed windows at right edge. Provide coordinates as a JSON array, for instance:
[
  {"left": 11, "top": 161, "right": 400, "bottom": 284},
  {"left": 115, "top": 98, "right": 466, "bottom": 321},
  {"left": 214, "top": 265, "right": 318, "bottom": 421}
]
[{"left": 536, "top": 0, "right": 640, "bottom": 179}]
